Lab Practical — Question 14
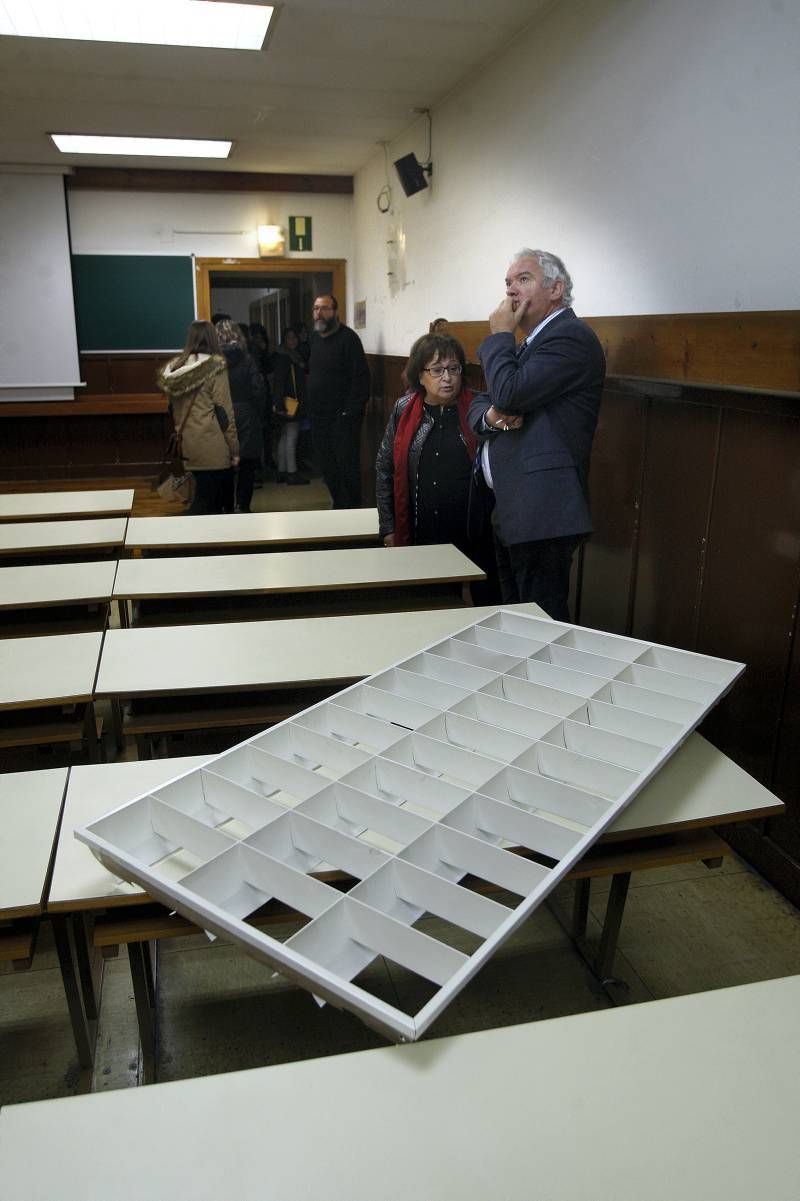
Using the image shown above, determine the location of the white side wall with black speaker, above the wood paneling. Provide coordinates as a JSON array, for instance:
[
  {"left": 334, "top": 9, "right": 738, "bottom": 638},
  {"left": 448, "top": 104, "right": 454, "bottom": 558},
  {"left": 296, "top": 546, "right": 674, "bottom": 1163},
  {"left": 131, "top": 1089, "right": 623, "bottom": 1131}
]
[{"left": 350, "top": 0, "right": 800, "bottom": 354}]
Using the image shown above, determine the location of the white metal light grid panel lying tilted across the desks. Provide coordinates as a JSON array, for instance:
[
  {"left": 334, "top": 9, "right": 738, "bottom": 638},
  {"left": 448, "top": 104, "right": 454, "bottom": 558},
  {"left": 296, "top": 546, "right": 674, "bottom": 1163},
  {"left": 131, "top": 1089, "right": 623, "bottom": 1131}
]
[{"left": 76, "top": 609, "right": 744, "bottom": 1041}]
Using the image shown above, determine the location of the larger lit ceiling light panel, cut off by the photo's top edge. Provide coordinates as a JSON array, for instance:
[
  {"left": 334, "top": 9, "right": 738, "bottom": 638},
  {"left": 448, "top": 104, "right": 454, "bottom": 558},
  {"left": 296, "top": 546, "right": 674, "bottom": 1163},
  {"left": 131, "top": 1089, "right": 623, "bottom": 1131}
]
[{"left": 0, "top": 0, "right": 274, "bottom": 50}]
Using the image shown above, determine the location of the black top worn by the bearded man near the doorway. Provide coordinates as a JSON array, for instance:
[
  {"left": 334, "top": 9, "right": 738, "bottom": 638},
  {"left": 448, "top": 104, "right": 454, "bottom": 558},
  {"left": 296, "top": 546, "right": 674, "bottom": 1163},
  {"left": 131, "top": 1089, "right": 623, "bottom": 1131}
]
[{"left": 308, "top": 325, "right": 370, "bottom": 420}]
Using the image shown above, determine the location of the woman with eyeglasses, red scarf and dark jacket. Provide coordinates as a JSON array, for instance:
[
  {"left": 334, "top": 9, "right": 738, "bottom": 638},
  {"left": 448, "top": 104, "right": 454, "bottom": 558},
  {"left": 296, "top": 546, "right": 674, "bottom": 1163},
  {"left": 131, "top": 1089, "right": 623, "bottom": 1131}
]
[{"left": 375, "top": 334, "right": 492, "bottom": 595}]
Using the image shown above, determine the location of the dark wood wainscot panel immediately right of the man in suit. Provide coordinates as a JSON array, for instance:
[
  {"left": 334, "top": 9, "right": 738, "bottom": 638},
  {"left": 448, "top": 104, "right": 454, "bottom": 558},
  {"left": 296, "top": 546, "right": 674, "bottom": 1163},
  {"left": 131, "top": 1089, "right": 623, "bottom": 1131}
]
[{"left": 575, "top": 384, "right": 647, "bottom": 633}]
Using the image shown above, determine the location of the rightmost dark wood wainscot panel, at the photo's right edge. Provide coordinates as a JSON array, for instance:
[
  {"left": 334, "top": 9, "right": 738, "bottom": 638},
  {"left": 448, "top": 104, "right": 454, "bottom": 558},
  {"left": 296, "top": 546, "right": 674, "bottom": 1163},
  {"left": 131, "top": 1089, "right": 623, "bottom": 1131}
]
[{"left": 697, "top": 410, "right": 800, "bottom": 785}]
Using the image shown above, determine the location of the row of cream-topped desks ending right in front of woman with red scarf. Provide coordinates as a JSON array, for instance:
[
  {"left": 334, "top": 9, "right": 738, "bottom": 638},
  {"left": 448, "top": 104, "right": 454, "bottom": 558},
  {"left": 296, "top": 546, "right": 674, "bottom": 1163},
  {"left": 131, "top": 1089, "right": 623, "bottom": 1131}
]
[{"left": 0, "top": 545, "right": 485, "bottom": 637}]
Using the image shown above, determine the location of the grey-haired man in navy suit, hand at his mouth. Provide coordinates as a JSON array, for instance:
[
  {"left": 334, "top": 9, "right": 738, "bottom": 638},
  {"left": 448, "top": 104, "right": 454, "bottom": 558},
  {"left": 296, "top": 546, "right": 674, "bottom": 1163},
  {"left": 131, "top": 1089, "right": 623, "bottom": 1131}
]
[{"left": 470, "top": 249, "right": 605, "bottom": 621}]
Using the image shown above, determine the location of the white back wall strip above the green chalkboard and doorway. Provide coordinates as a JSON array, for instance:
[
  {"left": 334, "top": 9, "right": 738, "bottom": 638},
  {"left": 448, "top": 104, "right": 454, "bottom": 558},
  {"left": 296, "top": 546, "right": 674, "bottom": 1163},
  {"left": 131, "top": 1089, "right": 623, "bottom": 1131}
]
[{"left": 68, "top": 191, "right": 353, "bottom": 259}]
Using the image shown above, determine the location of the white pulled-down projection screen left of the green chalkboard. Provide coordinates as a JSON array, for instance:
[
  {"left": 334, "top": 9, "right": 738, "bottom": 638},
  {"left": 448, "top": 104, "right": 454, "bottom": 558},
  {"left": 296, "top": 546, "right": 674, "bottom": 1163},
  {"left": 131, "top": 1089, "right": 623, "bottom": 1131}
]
[{"left": 0, "top": 172, "right": 80, "bottom": 401}]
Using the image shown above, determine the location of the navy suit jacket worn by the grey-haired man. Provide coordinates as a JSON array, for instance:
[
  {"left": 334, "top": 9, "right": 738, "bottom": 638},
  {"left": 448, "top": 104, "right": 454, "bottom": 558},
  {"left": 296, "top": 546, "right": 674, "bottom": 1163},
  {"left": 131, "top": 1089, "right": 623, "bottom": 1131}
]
[{"left": 470, "top": 309, "right": 605, "bottom": 545}]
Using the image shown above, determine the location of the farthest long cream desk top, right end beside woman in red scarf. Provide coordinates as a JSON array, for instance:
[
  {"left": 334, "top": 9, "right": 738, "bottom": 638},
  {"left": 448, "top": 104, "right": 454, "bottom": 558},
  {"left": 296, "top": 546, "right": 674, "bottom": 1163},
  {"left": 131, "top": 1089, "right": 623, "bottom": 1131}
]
[{"left": 125, "top": 509, "right": 378, "bottom": 550}]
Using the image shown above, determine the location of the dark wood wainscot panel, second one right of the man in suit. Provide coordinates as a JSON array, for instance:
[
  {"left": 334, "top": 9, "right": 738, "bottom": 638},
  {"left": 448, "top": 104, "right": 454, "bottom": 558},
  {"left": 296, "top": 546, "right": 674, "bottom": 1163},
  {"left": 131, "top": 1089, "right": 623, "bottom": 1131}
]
[{"left": 631, "top": 389, "right": 722, "bottom": 650}]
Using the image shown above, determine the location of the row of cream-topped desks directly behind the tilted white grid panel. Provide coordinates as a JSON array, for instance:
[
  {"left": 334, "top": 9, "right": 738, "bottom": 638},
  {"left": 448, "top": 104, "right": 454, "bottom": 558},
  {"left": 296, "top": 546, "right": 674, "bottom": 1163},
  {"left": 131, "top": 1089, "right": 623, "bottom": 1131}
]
[{"left": 0, "top": 600, "right": 511, "bottom": 751}]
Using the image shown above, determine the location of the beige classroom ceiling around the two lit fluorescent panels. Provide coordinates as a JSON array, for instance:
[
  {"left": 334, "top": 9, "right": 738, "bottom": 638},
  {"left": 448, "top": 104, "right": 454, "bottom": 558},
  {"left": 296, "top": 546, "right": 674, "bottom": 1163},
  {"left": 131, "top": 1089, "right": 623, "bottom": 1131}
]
[{"left": 0, "top": 0, "right": 551, "bottom": 174}]
